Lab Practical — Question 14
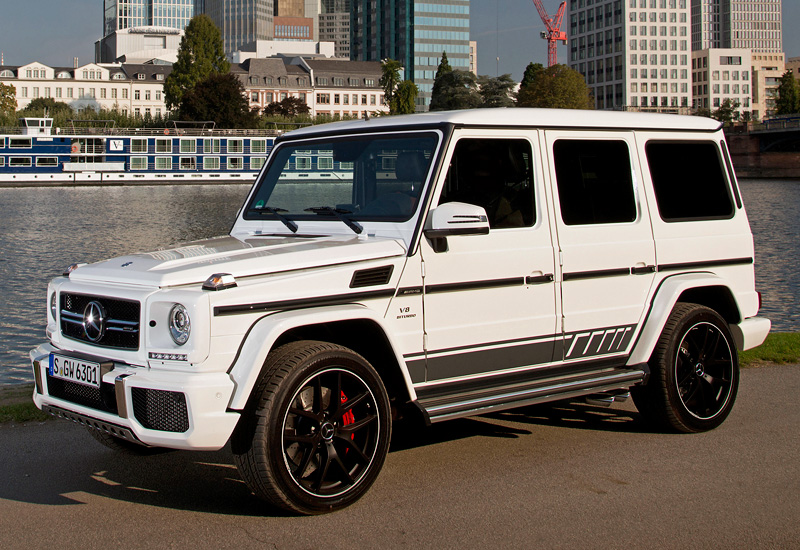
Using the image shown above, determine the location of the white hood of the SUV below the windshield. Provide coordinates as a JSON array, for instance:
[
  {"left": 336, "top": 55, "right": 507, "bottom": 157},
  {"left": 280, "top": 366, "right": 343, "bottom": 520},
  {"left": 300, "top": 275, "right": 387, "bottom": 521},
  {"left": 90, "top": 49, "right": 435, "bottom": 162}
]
[{"left": 64, "top": 236, "right": 406, "bottom": 287}]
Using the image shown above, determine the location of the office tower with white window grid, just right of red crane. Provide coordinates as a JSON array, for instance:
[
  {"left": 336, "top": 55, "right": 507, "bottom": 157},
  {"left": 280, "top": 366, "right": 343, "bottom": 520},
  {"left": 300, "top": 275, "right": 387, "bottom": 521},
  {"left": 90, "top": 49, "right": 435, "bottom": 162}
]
[{"left": 566, "top": 0, "right": 692, "bottom": 112}]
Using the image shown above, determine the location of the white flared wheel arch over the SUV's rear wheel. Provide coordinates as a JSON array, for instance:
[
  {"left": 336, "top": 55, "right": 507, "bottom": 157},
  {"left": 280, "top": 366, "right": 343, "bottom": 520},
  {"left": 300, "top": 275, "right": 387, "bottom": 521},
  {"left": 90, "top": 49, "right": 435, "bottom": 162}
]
[{"left": 628, "top": 273, "right": 743, "bottom": 365}]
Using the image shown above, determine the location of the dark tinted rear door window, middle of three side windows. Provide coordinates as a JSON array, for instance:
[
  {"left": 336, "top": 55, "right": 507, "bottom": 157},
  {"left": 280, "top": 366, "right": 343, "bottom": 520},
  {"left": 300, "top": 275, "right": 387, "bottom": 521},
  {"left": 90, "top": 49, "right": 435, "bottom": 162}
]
[{"left": 553, "top": 139, "right": 636, "bottom": 225}]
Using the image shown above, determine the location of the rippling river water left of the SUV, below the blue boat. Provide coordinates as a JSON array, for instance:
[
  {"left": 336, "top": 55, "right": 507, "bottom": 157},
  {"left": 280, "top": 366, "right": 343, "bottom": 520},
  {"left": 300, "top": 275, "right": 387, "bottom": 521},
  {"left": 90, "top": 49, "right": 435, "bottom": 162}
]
[{"left": 0, "top": 185, "right": 250, "bottom": 383}]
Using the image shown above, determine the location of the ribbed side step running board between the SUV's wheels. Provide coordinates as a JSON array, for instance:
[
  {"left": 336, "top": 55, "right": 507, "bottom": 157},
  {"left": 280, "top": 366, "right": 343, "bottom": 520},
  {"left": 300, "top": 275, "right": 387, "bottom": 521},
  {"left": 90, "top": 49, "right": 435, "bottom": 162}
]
[{"left": 417, "top": 369, "right": 646, "bottom": 423}]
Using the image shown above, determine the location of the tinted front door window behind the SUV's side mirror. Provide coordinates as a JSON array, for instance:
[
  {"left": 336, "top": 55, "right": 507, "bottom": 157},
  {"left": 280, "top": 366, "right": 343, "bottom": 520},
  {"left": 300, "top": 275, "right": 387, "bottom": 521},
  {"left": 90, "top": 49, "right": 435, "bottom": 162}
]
[{"left": 439, "top": 139, "right": 536, "bottom": 229}]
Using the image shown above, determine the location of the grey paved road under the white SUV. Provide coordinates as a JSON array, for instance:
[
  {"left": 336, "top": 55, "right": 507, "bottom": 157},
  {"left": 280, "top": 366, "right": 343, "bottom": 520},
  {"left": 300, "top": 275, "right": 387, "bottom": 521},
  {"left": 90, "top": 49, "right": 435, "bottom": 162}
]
[{"left": 0, "top": 366, "right": 800, "bottom": 550}]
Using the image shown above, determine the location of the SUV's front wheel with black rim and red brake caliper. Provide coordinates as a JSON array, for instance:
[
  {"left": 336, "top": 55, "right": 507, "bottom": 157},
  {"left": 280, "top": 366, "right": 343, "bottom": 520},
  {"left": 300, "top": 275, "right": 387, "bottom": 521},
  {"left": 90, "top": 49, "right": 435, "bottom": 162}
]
[{"left": 231, "top": 341, "right": 391, "bottom": 514}]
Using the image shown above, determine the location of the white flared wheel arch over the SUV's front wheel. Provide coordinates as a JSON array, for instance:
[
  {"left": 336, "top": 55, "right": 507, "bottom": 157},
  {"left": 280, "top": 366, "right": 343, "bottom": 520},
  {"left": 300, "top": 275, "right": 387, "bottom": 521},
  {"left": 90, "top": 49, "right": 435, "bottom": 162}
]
[{"left": 223, "top": 304, "right": 417, "bottom": 410}]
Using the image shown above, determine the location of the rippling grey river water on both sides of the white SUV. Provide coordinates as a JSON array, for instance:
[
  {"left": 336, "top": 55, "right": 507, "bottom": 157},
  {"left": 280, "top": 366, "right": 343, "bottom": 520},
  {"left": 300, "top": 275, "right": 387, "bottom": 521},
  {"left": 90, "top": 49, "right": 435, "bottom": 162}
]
[{"left": 0, "top": 180, "right": 800, "bottom": 384}]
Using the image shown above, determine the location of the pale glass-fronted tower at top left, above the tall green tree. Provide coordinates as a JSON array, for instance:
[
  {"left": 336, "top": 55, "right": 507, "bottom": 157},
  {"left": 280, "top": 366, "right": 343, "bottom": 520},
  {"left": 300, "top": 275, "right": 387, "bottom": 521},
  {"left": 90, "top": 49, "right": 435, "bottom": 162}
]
[{"left": 103, "top": 0, "right": 196, "bottom": 36}]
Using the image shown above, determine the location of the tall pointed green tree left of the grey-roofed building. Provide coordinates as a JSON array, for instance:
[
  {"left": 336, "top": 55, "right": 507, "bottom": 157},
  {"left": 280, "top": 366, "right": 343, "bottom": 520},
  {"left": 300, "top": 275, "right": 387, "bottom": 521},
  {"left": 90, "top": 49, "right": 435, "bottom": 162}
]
[{"left": 164, "top": 14, "right": 230, "bottom": 110}]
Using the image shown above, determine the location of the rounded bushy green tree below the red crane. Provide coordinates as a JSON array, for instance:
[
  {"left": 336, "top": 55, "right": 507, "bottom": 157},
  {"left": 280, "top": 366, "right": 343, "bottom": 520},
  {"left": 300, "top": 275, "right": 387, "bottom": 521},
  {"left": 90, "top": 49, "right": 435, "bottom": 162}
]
[{"left": 517, "top": 64, "right": 594, "bottom": 109}]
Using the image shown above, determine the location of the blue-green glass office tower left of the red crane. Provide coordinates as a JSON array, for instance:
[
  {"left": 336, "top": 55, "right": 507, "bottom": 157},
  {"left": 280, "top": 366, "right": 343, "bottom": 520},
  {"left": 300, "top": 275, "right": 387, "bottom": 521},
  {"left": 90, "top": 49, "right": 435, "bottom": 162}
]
[{"left": 350, "top": 0, "right": 470, "bottom": 111}]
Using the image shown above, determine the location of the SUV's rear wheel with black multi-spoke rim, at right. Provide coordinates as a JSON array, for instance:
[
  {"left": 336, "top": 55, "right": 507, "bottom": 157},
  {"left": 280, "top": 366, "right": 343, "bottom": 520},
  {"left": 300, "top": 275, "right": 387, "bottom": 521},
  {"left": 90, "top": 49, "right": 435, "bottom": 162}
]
[{"left": 631, "top": 303, "right": 739, "bottom": 433}]
